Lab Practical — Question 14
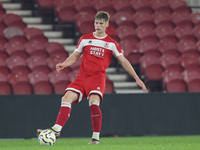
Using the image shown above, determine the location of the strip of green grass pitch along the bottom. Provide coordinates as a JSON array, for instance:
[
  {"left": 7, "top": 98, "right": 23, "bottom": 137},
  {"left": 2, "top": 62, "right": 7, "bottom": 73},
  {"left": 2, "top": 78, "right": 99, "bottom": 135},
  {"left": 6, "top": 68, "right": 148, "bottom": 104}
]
[{"left": 0, "top": 136, "right": 200, "bottom": 150}]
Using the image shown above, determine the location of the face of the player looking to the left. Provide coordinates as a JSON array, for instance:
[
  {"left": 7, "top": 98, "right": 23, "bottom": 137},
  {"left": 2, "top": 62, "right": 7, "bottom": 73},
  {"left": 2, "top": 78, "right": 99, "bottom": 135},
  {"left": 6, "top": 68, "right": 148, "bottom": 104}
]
[{"left": 94, "top": 19, "right": 108, "bottom": 34}]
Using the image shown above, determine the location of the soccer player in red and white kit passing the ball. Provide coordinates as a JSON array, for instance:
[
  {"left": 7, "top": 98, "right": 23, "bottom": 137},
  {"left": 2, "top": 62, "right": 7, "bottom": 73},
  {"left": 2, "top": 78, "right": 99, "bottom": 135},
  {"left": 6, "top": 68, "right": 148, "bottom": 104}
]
[{"left": 37, "top": 11, "right": 147, "bottom": 144}]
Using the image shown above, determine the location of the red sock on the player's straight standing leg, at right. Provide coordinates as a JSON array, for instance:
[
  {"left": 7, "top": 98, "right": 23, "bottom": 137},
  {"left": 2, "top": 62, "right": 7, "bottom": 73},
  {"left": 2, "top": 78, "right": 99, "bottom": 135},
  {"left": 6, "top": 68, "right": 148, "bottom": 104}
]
[{"left": 90, "top": 105, "right": 102, "bottom": 132}]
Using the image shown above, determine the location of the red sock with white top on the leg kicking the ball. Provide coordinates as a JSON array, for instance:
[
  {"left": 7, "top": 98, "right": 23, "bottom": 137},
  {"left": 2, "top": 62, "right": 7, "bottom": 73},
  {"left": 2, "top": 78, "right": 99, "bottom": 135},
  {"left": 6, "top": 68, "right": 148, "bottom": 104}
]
[{"left": 56, "top": 102, "right": 71, "bottom": 127}]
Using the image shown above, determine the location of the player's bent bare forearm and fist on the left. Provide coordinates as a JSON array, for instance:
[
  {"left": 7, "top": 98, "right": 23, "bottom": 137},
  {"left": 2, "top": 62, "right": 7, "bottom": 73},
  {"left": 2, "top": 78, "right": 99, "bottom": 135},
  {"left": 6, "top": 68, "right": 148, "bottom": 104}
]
[{"left": 56, "top": 51, "right": 82, "bottom": 72}]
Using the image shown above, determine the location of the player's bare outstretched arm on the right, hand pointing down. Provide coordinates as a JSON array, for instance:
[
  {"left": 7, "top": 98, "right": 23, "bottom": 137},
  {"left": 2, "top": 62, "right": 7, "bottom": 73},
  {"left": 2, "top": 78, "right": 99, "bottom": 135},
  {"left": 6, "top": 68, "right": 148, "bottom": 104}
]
[{"left": 116, "top": 55, "right": 147, "bottom": 92}]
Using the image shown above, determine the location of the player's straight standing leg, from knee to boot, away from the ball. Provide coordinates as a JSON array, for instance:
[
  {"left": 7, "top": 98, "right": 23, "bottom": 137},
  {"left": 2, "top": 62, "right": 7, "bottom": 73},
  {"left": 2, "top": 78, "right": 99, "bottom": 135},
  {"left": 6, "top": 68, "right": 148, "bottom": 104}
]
[{"left": 88, "top": 94, "right": 102, "bottom": 144}]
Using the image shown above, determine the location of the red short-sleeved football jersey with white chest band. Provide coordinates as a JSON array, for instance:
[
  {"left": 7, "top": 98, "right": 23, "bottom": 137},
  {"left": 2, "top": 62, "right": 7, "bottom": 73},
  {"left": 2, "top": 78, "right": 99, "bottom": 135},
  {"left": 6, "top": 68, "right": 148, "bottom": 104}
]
[{"left": 75, "top": 33, "right": 122, "bottom": 76}]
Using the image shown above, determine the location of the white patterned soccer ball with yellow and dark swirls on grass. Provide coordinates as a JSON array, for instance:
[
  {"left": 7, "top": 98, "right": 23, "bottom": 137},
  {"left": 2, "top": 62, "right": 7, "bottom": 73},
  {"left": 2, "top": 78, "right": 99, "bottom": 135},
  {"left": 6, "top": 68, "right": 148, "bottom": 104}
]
[{"left": 38, "top": 129, "right": 56, "bottom": 145}]
